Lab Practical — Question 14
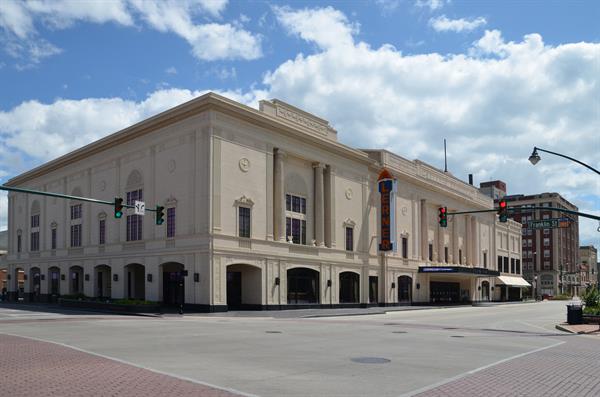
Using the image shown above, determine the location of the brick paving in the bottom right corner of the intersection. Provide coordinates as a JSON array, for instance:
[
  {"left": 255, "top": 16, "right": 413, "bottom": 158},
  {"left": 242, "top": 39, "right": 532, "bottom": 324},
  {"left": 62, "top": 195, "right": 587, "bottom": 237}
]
[{"left": 416, "top": 335, "right": 600, "bottom": 397}]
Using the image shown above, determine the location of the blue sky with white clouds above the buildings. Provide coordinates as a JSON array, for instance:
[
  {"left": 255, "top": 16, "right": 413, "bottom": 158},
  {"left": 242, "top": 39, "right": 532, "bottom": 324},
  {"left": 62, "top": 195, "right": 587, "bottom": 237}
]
[{"left": 0, "top": 0, "right": 600, "bottom": 247}]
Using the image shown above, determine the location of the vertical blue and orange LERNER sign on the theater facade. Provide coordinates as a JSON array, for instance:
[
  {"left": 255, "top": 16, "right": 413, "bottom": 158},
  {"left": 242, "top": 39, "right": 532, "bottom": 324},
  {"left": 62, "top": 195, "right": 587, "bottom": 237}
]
[{"left": 377, "top": 169, "right": 396, "bottom": 251}]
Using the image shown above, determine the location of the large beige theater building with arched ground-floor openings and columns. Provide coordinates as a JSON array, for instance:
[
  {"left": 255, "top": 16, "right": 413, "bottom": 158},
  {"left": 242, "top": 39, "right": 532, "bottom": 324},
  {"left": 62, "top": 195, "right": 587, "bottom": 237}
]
[{"left": 3, "top": 93, "right": 528, "bottom": 311}]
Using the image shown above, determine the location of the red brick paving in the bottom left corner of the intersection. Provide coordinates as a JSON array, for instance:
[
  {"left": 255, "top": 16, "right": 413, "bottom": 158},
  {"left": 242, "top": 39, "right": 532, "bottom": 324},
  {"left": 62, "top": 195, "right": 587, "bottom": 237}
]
[{"left": 0, "top": 334, "right": 244, "bottom": 397}]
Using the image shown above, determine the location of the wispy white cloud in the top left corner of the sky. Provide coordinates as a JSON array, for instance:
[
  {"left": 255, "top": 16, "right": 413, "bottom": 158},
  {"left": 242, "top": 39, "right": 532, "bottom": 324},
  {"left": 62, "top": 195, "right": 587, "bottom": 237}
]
[{"left": 0, "top": 0, "right": 262, "bottom": 65}]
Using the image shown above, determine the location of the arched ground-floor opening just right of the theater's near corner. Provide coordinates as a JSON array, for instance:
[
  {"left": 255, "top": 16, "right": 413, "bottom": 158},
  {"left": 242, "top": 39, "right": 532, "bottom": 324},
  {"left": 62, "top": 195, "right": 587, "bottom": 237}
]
[{"left": 227, "top": 264, "right": 262, "bottom": 310}]
